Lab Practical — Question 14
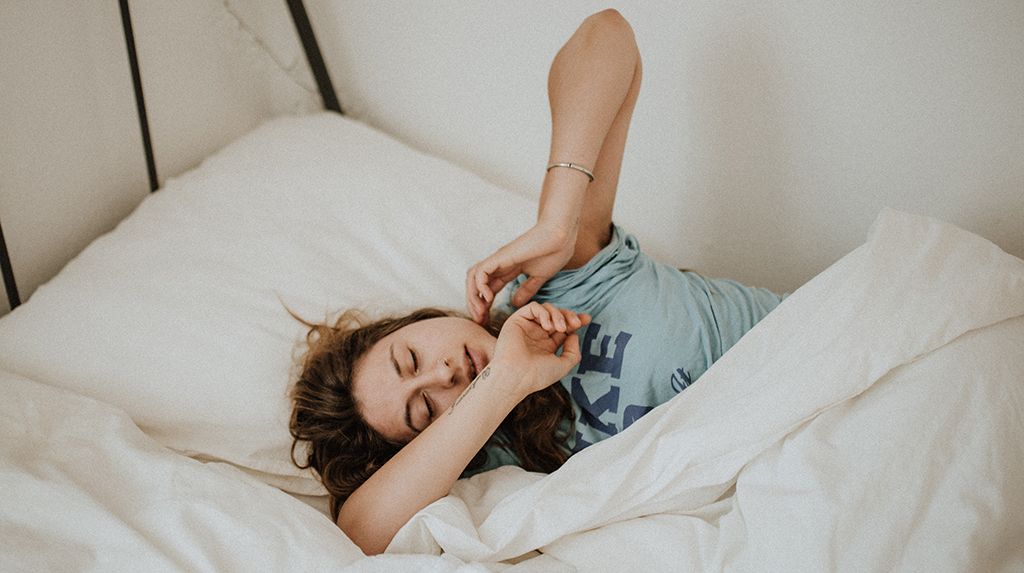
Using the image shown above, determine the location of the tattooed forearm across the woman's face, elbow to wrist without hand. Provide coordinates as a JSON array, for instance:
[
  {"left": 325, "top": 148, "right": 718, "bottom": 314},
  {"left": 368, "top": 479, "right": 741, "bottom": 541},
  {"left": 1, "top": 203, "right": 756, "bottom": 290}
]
[{"left": 338, "top": 364, "right": 524, "bottom": 555}]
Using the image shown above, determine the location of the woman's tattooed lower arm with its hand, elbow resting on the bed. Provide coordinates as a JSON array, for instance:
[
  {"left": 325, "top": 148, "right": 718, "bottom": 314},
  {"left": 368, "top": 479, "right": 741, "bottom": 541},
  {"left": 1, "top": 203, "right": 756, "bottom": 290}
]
[{"left": 338, "top": 303, "right": 590, "bottom": 555}]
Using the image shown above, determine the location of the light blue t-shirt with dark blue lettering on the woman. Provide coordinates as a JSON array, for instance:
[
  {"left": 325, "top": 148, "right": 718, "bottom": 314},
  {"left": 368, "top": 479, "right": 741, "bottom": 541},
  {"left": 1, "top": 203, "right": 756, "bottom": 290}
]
[{"left": 464, "top": 225, "right": 782, "bottom": 477}]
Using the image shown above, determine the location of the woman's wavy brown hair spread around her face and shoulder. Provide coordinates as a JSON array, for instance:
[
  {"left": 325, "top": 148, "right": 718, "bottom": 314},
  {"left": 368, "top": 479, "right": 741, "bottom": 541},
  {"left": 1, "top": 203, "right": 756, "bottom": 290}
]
[{"left": 289, "top": 308, "right": 573, "bottom": 521}]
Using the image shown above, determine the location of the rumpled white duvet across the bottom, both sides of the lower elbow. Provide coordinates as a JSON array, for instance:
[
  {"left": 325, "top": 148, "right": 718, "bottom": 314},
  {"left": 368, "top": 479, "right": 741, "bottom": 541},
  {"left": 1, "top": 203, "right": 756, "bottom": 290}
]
[{"left": 0, "top": 206, "right": 1024, "bottom": 571}]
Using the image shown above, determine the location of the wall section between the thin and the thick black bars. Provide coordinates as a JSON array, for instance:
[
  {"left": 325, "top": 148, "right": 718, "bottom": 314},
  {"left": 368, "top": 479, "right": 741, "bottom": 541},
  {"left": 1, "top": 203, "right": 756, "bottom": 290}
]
[{"left": 131, "top": 0, "right": 321, "bottom": 182}]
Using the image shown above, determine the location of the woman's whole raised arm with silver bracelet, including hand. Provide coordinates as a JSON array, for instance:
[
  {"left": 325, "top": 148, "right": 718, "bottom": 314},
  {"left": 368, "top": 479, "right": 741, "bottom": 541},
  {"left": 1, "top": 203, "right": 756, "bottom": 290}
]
[{"left": 466, "top": 10, "right": 642, "bottom": 322}]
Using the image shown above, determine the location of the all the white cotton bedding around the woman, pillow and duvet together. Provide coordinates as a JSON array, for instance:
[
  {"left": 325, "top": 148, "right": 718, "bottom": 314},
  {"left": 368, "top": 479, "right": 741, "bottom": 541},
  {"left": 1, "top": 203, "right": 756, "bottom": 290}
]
[{"left": 0, "top": 108, "right": 1024, "bottom": 573}]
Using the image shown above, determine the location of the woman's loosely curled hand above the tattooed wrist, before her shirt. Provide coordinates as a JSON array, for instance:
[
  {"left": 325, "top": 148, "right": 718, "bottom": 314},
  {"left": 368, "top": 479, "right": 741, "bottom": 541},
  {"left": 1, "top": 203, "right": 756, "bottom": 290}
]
[{"left": 492, "top": 302, "right": 590, "bottom": 397}]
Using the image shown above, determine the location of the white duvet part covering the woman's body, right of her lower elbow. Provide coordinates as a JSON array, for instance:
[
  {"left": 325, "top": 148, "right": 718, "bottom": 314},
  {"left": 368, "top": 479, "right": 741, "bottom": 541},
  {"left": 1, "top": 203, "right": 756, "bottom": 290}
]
[{"left": 389, "top": 206, "right": 1024, "bottom": 571}]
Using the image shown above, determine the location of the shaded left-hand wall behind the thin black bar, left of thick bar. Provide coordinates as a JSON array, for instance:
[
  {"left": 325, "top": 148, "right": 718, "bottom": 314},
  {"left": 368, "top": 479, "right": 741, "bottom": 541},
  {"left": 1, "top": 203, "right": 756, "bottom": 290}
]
[{"left": 0, "top": 0, "right": 319, "bottom": 313}]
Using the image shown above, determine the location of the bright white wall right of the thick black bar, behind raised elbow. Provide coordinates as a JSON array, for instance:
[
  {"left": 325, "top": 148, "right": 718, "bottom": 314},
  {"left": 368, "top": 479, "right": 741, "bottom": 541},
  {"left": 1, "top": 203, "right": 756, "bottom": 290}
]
[{"left": 312, "top": 0, "right": 1024, "bottom": 291}]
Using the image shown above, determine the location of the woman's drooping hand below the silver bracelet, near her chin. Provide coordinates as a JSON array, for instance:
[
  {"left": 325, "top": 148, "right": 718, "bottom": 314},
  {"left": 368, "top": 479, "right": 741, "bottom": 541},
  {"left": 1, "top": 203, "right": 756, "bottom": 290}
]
[{"left": 466, "top": 221, "right": 579, "bottom": 324}]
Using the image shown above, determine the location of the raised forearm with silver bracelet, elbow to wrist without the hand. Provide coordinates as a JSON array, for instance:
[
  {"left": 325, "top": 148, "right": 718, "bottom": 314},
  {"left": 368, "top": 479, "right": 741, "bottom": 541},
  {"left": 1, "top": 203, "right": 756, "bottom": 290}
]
[{"left": 538, "top": 10, "right": 640, "bottom": 235}]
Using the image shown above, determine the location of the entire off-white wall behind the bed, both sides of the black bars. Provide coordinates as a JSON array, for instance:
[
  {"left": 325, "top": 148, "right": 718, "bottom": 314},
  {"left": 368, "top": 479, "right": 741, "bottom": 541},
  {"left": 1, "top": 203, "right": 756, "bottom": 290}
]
[{"left": 0, "top": 0, "right": 1024, "bottom": 312}]
